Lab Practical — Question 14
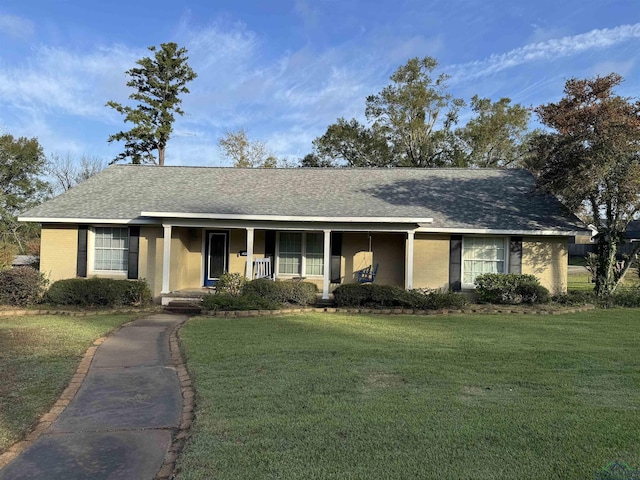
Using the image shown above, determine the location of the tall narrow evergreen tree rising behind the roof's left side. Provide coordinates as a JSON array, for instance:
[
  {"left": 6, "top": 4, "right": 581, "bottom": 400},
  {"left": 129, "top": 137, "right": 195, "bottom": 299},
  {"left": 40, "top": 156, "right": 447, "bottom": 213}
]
[{"left": 107, "top": 42, "right": 197, "bottom": 165}]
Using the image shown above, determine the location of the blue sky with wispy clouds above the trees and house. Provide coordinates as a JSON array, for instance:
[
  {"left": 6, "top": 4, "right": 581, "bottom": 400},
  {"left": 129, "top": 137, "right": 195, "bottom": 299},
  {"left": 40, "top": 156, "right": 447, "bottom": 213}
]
[{"left": 0, "top": 0, "right": 640, "bottom": 166}]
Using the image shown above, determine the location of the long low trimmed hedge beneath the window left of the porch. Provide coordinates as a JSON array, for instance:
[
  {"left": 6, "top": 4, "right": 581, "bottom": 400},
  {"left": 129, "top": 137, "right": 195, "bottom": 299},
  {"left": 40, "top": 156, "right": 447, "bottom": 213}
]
[{"left": 44, "top": 278, "right": 152, "bottom": 307}]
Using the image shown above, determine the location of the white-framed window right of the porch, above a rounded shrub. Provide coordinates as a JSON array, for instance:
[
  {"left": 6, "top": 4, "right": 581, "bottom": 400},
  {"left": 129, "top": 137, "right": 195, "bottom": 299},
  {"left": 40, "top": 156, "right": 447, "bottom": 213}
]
[{"left": 462, "top": 237, "right": 508, "bottom": 287}]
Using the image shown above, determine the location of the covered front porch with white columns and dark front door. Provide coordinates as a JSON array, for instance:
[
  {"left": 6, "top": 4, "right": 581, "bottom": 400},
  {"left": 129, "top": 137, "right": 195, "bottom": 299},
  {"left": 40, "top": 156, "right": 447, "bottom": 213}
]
[{"left": 150, "top": 224, "right": 414, "bottom": 300}]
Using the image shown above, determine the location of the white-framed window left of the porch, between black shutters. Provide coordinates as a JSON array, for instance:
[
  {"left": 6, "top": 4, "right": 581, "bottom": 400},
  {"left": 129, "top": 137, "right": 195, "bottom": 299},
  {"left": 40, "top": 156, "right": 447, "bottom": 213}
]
[{"left": 93, "top": 227, "right": 129, "bottom": 272}]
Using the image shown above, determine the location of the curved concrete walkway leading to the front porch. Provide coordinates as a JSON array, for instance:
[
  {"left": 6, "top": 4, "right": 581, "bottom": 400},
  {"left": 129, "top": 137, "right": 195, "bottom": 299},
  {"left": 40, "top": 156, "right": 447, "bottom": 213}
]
[{"left": 0, "top": 314, "right": 186, "bottom": 480}]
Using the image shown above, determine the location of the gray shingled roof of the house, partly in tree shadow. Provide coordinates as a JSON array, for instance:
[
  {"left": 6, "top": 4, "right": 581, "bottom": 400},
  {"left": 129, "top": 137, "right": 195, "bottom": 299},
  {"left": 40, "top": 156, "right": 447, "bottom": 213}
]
[{"left": 21, "top": 165, "right": 584, "bottom": 231}]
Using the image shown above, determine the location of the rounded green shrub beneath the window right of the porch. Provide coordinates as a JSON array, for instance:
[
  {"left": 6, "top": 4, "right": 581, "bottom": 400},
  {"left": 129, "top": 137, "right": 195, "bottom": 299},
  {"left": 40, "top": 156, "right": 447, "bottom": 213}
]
[{"left": 475, "top": 273, "right": 550, "bottom": 305}]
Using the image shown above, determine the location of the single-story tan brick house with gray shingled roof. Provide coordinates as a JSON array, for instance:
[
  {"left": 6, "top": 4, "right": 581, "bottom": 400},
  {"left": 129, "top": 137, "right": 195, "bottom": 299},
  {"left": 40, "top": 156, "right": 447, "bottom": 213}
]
[{"left": 20, "top": 165, "right": 590, "bottom": 298}]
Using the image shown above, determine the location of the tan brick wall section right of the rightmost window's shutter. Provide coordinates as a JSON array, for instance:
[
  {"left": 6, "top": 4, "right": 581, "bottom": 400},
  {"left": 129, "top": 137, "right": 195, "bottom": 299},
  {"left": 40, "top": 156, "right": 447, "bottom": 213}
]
[{"left": 522, "top": 237, "right": 569, "bottom": 294}]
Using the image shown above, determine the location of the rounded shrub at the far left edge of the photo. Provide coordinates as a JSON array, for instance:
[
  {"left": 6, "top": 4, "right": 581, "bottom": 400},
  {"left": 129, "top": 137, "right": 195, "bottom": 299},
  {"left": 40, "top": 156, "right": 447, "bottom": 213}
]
[{"left": 0, "top": 267, "right": 48, "bottom": 307}]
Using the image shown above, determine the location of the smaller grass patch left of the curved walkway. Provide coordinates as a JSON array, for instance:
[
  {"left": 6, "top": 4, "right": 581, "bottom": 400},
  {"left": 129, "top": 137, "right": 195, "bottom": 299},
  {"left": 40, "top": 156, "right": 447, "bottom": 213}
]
[{"left": 0, "top": 315, "right": 132, "bottom": 452}]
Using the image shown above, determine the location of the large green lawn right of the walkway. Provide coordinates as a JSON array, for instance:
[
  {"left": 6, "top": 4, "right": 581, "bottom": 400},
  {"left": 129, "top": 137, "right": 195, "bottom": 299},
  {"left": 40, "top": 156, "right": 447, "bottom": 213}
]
[{"left": 178, "top": 309, "right": 640, "bottom": 480}]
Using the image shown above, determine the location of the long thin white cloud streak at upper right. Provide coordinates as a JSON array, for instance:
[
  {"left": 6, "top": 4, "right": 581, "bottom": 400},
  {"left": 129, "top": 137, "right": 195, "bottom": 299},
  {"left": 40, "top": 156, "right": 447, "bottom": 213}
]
[{"left": 447, "top": 23, "right": 640, "bottom": 82}]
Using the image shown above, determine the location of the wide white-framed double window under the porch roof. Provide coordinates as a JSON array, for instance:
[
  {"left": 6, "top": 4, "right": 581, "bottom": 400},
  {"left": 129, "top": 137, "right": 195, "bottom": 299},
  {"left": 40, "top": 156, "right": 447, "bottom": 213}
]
[{"left": 277, "top": 232, "right": 324, "bottom": 277}]
